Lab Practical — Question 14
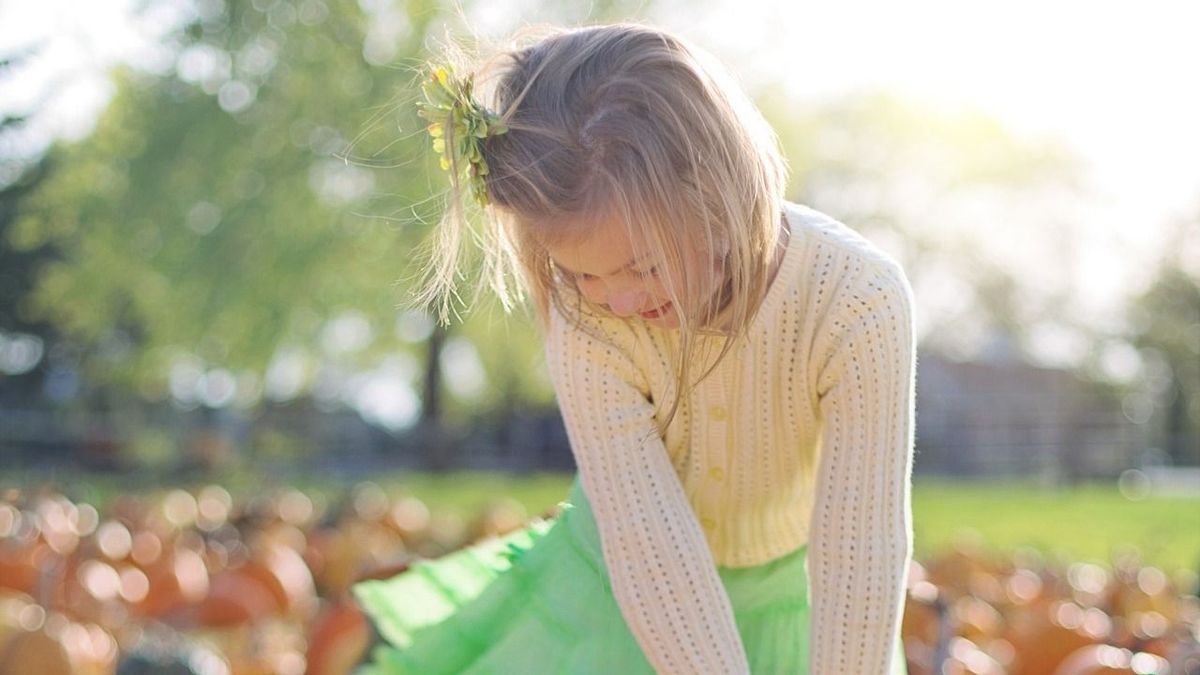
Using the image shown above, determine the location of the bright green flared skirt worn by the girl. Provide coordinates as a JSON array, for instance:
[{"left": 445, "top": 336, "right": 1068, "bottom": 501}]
[{"left": 354, "top": 477, "right": 905, "bottom": 675}]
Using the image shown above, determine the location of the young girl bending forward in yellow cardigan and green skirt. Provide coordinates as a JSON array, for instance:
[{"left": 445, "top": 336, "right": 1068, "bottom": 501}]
[{"left": 356, "top": 25, "right": 914, "bottom": 675}]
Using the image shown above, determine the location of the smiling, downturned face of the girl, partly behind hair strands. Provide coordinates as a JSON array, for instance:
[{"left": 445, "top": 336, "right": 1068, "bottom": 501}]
[{"left": 546, "top": 222, "right": 721, "bottom": 328}]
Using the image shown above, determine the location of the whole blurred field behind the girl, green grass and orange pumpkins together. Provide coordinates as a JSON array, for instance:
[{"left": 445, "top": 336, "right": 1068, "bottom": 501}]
[{"left": 0, "top": 464, "right": 1200, "bottom": 675}]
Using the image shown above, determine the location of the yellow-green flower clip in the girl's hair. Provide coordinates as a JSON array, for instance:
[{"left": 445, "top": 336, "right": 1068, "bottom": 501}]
[{"left": 418, "top": 66, "right": 508, "bottom": 207}]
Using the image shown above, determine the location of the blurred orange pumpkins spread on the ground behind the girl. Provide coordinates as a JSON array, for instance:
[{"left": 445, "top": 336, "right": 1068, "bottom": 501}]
[{"left": 0, "top": 483, "right": 1200, "bottom": 675}]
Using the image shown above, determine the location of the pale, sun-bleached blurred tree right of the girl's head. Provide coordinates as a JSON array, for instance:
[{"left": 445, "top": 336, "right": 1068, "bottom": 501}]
[{"left": 758, "top": 85, "right": 1094, "bottom": 365}]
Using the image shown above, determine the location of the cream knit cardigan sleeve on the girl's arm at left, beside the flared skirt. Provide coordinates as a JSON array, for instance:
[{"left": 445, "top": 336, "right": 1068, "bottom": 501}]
[{"left": 546, "top": 303, "right": 749, "bottom": 675}]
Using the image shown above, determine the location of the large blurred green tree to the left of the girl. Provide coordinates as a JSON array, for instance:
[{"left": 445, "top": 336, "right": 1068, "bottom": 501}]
[{"left": 6, "top": 0, "right": 662, "bottom": 461}]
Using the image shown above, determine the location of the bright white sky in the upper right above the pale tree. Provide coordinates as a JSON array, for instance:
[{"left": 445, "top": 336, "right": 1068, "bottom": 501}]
[{"left": 672, "top": 0, "right": 1200, "bottom": 253}]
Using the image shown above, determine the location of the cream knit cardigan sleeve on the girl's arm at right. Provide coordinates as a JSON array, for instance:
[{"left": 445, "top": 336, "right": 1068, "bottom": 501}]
[{"left": 808, "top": 254, "right": 916, "bottom": 675}]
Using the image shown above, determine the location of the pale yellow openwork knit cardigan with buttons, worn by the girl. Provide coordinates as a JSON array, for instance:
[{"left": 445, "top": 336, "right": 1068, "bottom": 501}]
[{"left": 546, "top": 203, "right": 916, "bottom": 675}]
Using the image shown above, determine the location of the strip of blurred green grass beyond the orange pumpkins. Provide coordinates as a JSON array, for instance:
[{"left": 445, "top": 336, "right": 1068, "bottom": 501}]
[{"left": 0, "top": 471, "right": 1200, "bottom": 573}]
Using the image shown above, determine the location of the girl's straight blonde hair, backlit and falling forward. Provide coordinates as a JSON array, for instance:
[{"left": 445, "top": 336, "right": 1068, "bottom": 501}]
[{"left": 416, "top": 24, "right": 786, "bottom": 431}]
